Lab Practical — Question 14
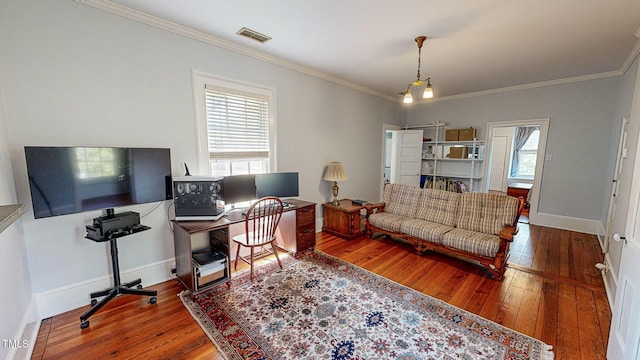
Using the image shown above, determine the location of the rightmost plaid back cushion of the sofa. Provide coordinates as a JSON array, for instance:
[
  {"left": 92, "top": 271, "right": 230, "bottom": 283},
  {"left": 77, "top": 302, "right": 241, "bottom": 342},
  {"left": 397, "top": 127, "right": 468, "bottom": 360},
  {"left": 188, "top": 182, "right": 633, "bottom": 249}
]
[{"left": 456, "top": 192, "right": 519, "bottom": 235}]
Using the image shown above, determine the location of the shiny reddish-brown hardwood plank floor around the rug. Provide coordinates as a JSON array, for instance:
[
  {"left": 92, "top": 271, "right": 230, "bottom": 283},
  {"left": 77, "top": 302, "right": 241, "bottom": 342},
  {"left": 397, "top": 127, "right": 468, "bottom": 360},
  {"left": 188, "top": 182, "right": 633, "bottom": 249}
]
[{"left": 32, "top": 224, "right": 611, "bottom": 360}]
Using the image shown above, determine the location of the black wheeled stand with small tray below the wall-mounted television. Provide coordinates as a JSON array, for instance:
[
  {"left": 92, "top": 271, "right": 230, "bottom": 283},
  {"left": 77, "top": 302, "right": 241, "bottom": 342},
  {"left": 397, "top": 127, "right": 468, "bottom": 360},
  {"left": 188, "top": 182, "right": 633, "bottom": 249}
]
[{"left": 80, "top": 224, "right": 158, "bottom": 329}]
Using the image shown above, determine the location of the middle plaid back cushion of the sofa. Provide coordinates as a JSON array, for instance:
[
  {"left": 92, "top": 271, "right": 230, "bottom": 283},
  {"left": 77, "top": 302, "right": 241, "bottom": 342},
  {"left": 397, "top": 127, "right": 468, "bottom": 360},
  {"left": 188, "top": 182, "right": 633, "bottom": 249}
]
[{"left": 416, "top": 189, "right": 460, "bottom": 227}]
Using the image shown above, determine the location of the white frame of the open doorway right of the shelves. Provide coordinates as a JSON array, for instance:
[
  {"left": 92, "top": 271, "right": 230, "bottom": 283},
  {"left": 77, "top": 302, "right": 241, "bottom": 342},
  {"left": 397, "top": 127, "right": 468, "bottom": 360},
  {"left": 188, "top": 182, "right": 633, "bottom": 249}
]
[{"left": 482, "top": 118, "right": 550, "bottom": 224}]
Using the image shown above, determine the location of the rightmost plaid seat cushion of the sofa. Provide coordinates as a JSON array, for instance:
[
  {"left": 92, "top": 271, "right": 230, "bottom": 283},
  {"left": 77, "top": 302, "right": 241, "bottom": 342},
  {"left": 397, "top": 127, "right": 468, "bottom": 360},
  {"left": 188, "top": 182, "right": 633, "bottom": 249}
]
[{"left": 442, "top": 229, "right": 500, "bottom": 257}]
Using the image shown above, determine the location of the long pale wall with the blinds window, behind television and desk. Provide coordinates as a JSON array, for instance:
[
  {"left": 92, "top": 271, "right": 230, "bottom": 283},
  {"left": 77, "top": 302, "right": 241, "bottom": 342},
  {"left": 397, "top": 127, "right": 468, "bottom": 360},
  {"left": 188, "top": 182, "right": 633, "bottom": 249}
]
[{"left": 0, "top": 0, "right": 405, "bottom": 316}]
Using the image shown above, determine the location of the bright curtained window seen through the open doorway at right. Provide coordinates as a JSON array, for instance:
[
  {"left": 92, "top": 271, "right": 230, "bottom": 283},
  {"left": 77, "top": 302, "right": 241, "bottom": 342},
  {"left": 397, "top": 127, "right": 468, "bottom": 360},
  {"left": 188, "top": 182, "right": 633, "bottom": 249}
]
[{"left": 511, "top": 126, "right": 540, "bottom": 179}]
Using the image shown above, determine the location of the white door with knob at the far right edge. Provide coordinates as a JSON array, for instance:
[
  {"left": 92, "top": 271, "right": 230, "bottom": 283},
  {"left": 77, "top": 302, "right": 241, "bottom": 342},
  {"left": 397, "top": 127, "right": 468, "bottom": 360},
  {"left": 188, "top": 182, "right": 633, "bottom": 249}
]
[{"left": 607, "top": 128, "right": 640, "bottom": 360}]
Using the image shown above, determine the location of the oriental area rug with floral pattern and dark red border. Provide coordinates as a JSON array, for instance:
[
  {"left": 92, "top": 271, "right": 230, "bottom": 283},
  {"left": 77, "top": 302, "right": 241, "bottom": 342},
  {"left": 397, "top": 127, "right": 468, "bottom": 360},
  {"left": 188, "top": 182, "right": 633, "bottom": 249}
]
[{"left": 180, "top": 251, "right": 554, "bottom": 360}]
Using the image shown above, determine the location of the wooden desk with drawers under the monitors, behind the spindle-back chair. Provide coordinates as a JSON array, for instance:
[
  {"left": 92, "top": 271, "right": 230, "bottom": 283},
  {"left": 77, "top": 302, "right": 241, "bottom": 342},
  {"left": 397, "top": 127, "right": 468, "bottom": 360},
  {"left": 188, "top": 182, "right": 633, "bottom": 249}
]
[{"left": 173, "top": 199, "right": 316, "bottom": 293}]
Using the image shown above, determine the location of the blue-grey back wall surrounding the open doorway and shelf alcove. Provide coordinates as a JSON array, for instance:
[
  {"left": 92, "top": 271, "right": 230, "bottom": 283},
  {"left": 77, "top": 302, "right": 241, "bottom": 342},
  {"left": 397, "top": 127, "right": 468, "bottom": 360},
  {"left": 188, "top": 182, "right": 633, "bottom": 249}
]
[{"left": 407, "top": 78, "right": 620, "bottom": 232}]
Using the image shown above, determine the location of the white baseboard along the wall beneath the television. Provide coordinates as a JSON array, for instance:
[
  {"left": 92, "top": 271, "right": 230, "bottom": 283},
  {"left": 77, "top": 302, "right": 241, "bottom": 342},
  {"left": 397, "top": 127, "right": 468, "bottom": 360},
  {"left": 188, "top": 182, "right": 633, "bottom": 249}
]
[{"left": 34, "top": 259, "right": 175, "bottom": 323}]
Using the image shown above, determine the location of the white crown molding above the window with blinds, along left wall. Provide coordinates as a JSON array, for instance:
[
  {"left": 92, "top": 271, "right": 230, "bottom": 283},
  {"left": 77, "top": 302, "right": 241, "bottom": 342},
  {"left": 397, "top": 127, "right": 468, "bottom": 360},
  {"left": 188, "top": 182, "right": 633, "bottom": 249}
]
[{"left": 74, "top": 0, "right": 398, "bottom": 102}]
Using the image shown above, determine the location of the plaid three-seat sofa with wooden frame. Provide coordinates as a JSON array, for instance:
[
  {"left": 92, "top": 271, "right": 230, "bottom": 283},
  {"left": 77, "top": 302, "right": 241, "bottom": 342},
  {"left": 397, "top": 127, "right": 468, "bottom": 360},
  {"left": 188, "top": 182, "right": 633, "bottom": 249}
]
[{"left": 366, "top": 184, "right": 524, "bottom": 281}]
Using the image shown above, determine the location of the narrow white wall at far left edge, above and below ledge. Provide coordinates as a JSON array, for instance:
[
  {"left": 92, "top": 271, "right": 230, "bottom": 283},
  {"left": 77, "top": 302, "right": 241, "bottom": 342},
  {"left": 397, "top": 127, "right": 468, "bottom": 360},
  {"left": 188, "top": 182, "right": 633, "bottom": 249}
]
[{"left": 0, "top": 71, "right": 35, "bottom": 359}]
